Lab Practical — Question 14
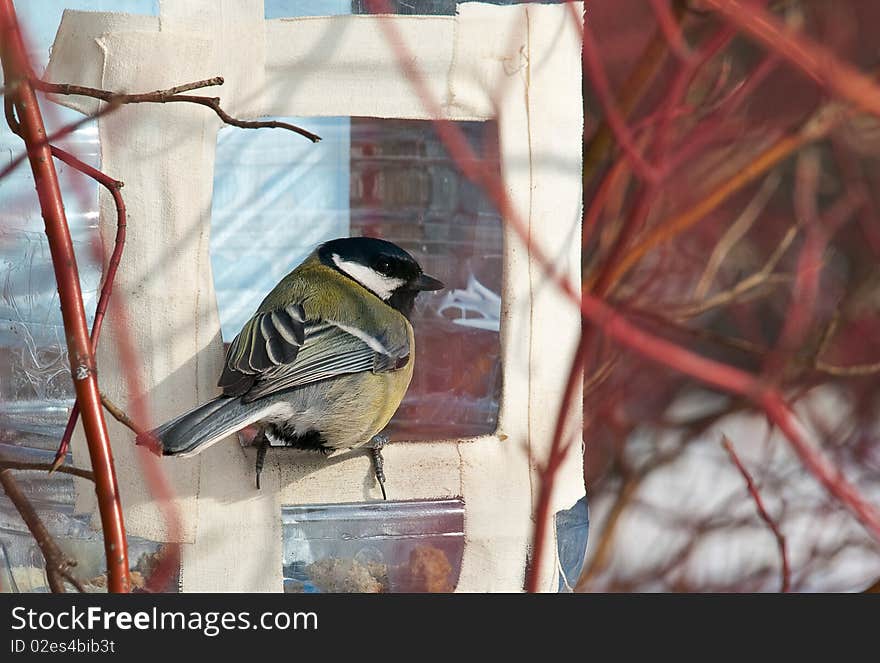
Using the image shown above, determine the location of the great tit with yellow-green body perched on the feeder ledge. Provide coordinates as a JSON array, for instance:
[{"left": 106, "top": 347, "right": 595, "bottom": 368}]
[{"left": 148, "top": 237, "right": 444, "bottom": 494}]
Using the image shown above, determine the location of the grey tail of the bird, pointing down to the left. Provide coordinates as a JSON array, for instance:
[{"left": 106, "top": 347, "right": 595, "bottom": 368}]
[{"left": 138, "top": 396, "right": 276, "bottom": 457}]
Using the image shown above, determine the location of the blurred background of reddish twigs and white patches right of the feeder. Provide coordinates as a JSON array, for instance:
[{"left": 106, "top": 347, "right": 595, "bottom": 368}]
[{"left": 578, "top": 0, "right": 880, "bottom": 591}]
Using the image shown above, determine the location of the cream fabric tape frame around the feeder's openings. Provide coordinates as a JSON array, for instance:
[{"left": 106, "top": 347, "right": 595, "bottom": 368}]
[{"left": 47, "top": 0, "right": 584, "bottom": 591}]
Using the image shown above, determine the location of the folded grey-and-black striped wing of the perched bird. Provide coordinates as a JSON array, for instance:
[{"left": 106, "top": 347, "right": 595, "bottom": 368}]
[{"left": 219, "top": 306, "right": 410, "bottom": 402}]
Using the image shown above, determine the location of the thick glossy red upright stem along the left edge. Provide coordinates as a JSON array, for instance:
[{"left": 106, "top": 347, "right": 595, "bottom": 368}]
[{"left": 0, "top": 0, "right": 130, "bottom": 592}]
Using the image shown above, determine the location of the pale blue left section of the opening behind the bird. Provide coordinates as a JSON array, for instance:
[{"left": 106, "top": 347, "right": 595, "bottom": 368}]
[{"left": 211, "top": 117, "right": 351, "bottom": 342}]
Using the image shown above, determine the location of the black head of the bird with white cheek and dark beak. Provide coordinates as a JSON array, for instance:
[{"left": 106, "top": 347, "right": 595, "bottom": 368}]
[{"left": 318, "top": 237, "right": 443, "bottom": 317}]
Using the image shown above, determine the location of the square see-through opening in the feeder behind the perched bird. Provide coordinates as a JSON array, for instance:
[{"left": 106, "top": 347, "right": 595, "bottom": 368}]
[{"left": 211, "top": 117, "right": 503, "bottom": 441}]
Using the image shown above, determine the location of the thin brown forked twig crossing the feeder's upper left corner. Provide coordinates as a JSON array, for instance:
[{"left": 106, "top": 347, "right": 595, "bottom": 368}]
[{"left": 33, "top": 76, "right": 321, "bottom": 143}]
